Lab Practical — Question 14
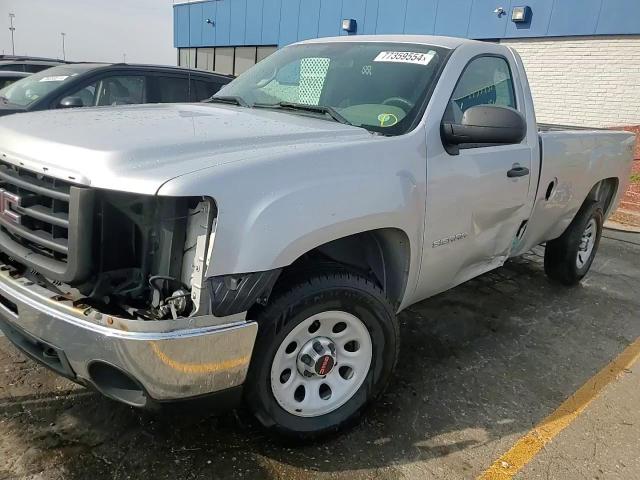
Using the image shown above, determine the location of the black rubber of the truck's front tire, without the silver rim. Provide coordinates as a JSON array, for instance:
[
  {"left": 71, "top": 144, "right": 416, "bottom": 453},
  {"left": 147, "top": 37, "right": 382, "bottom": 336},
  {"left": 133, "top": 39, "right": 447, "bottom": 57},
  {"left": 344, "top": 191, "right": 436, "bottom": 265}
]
[{"left": 245, "top": 272, "right": 399, "bottom": 440}]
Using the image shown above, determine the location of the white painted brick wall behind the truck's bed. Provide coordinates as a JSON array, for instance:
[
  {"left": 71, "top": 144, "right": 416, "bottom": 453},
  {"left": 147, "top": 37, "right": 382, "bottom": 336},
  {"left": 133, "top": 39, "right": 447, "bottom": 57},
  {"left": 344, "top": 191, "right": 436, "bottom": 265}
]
[{"left": 501, "top": 36, "right": 640, "bottom": 127}]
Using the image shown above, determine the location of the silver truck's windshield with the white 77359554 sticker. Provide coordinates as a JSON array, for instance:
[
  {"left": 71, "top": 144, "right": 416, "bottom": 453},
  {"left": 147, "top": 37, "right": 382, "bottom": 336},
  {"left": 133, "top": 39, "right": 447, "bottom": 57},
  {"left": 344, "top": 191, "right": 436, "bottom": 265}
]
[{"left": 214, "top": 42, "right": 448, "bottom": 135}]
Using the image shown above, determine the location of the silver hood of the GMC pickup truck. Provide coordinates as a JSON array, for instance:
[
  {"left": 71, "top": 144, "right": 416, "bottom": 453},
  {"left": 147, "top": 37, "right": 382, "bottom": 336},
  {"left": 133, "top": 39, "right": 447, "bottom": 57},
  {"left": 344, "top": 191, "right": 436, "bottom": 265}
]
[{"left": 0, "top": 104, "right": 371, "bottom": 194}]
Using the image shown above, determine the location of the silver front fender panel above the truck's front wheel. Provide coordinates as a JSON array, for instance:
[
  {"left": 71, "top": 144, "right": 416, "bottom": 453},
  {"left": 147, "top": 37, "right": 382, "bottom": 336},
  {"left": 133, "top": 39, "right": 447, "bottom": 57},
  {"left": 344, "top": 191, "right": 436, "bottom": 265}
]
[{"left": 158, "top": 136, "right": 426, "bottom": 277}]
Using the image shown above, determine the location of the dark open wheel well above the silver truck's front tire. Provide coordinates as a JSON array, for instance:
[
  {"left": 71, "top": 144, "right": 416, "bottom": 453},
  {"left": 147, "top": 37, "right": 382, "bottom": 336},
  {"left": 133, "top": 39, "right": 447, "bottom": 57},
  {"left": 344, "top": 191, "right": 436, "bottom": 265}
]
[{"left": 274, "top": 228, "right": 411, "bottom": 306}]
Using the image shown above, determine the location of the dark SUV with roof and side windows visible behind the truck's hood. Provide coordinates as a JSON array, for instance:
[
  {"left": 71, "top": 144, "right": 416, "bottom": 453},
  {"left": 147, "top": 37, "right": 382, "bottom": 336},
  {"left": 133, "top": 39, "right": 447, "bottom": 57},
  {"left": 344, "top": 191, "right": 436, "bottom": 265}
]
[{"left": 0, "top": 63, "right": 233, "bottom": 116}]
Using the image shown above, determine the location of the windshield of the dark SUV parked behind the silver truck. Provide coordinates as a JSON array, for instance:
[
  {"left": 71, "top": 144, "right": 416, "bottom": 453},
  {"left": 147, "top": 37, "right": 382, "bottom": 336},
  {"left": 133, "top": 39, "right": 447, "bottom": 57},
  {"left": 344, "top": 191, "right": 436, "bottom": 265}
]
[{"left": 0, "top": 66, "right": 87, "bottom": 107}]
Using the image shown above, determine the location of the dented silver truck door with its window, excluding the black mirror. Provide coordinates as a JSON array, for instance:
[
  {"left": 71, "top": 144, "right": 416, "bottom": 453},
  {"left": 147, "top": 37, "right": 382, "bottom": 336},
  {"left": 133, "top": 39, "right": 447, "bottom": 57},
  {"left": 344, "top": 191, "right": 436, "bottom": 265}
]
[{"left": 417, "top": 55, "right": 535, "bottom": 298}]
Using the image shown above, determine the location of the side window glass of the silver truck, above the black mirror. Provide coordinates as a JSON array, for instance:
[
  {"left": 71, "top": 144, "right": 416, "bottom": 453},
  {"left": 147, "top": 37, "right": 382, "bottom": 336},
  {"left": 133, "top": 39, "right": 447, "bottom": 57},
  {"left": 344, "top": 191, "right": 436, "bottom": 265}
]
[{"left": 444, "top": 57, "right": 516, "bottom": 123}]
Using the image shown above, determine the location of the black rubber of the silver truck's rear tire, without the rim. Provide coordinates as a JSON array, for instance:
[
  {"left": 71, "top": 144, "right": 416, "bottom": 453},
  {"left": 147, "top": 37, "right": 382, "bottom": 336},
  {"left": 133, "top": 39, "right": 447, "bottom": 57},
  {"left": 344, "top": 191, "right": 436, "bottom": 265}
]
[{"left": 544, "top": 202, "right": 604, "bottom": 286}]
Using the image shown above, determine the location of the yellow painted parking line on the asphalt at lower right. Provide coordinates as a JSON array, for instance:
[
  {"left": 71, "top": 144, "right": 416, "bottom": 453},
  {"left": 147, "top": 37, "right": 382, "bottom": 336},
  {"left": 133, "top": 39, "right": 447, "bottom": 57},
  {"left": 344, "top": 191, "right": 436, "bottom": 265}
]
[{"left": 477, "top": 337, "right": 640, "bottom": 480}]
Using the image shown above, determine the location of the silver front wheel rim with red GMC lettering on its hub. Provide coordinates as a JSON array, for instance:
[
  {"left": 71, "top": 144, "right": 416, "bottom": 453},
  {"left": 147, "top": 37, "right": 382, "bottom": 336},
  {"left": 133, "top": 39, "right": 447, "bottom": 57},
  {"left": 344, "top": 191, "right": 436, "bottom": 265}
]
[{"left": 271, "top": 311, "right": 373, "bottom": 417}]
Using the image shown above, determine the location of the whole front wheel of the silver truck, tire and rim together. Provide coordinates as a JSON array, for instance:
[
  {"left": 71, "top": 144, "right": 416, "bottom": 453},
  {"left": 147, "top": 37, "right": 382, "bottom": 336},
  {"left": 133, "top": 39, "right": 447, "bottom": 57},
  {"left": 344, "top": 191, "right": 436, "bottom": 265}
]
[{"left": 245, "top": 272, "right": 399, "bottom": 438}]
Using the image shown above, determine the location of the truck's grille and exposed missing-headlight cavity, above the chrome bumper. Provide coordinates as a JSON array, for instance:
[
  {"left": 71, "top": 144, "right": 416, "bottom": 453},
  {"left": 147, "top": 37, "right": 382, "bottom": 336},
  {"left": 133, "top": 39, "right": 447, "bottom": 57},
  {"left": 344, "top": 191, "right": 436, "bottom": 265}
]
[{"left": 0, "top": 158, "right": 279, "bottom": 320}]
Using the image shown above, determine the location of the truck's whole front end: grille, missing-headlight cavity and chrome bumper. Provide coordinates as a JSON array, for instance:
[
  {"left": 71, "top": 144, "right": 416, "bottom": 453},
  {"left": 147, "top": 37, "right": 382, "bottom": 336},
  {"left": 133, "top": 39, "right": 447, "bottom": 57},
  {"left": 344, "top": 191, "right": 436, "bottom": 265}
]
[{"left": 0, "top": 160, "right": 264, "bottom": 407}]
